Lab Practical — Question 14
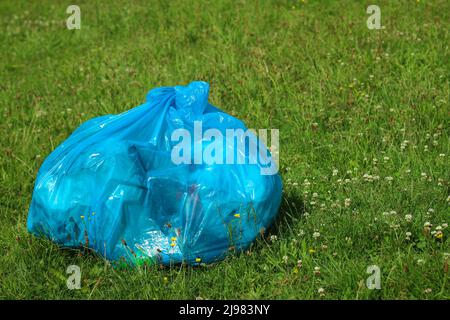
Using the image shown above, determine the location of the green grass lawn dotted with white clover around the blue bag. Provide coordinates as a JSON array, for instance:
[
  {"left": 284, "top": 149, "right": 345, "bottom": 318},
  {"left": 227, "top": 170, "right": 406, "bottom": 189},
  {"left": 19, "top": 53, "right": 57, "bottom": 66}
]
[{"left": 0, "top": 0, "right": 450, "bottom": 299}]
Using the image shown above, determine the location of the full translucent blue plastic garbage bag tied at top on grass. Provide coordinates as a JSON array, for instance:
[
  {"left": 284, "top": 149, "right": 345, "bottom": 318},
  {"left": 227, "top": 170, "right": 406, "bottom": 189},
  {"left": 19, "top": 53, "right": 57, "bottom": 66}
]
[{"left": 28, "top": 82, "right": 282, "bottom": 264}]
